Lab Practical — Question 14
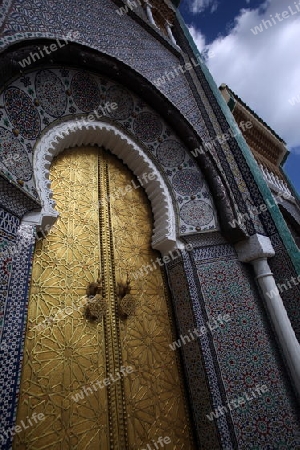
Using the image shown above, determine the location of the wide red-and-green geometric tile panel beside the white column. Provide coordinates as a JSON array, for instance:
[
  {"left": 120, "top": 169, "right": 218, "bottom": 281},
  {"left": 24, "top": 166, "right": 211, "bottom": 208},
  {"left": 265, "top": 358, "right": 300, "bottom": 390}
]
[{"left": 187, "top": 238, "right": 300, "bottom": 450}]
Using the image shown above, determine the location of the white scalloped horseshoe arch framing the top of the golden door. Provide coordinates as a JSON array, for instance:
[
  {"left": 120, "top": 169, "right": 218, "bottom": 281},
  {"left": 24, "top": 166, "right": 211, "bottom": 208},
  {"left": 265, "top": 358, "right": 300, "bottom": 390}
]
[{"left": 23, "top": 119, "right": 180, "bottom": 254}]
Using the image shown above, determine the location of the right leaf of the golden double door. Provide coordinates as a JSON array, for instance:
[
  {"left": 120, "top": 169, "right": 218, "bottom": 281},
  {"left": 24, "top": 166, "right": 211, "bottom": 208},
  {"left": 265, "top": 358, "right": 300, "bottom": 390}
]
[{"left": 108, "top": 156, "right": 193, "bottom": 450}]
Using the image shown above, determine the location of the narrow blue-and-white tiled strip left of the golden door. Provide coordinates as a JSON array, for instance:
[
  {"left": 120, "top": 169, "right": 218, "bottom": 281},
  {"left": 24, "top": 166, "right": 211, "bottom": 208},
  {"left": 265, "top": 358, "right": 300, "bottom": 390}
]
[{"left": 0, "top": 224, "right": 35, "bottom": 450}]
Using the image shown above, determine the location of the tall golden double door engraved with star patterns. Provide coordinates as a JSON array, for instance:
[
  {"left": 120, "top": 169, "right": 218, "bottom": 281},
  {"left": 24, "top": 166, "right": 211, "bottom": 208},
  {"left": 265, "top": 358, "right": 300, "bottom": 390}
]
[{"left": 13, "top": 147, "right": 195, "bottom": 450}]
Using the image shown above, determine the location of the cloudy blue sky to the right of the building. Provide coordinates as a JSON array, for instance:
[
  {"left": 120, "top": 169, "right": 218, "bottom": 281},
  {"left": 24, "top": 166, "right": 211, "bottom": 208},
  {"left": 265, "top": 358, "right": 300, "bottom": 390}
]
[{"left": 179, "top": 0, "right": 300, "bottom": 193}]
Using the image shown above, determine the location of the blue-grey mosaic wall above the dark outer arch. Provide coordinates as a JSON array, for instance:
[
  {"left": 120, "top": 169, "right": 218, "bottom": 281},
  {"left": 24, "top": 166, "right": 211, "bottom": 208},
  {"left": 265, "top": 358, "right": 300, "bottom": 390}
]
[{"left": 0, "top": 0, "right": 264, "bottom": 234}]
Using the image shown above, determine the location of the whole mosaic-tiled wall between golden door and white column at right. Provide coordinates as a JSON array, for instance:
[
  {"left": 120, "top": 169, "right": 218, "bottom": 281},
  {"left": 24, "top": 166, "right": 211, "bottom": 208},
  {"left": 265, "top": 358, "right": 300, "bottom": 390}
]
[{"left": 168, "top": 234, "right": 300, "bottom": 450}]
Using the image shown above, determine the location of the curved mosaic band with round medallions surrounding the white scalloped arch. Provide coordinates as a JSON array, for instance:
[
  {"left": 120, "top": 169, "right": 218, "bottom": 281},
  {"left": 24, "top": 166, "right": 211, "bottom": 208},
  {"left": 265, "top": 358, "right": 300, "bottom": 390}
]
[{"left": 0, "top": 68, "right": 218, "bottom": 234}]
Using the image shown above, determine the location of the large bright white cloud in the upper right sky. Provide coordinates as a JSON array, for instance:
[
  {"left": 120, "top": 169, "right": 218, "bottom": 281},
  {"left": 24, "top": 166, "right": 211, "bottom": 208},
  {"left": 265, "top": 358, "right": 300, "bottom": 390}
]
[{"left": 190, "top": 0, "right": 300, "bottom": 147}]
